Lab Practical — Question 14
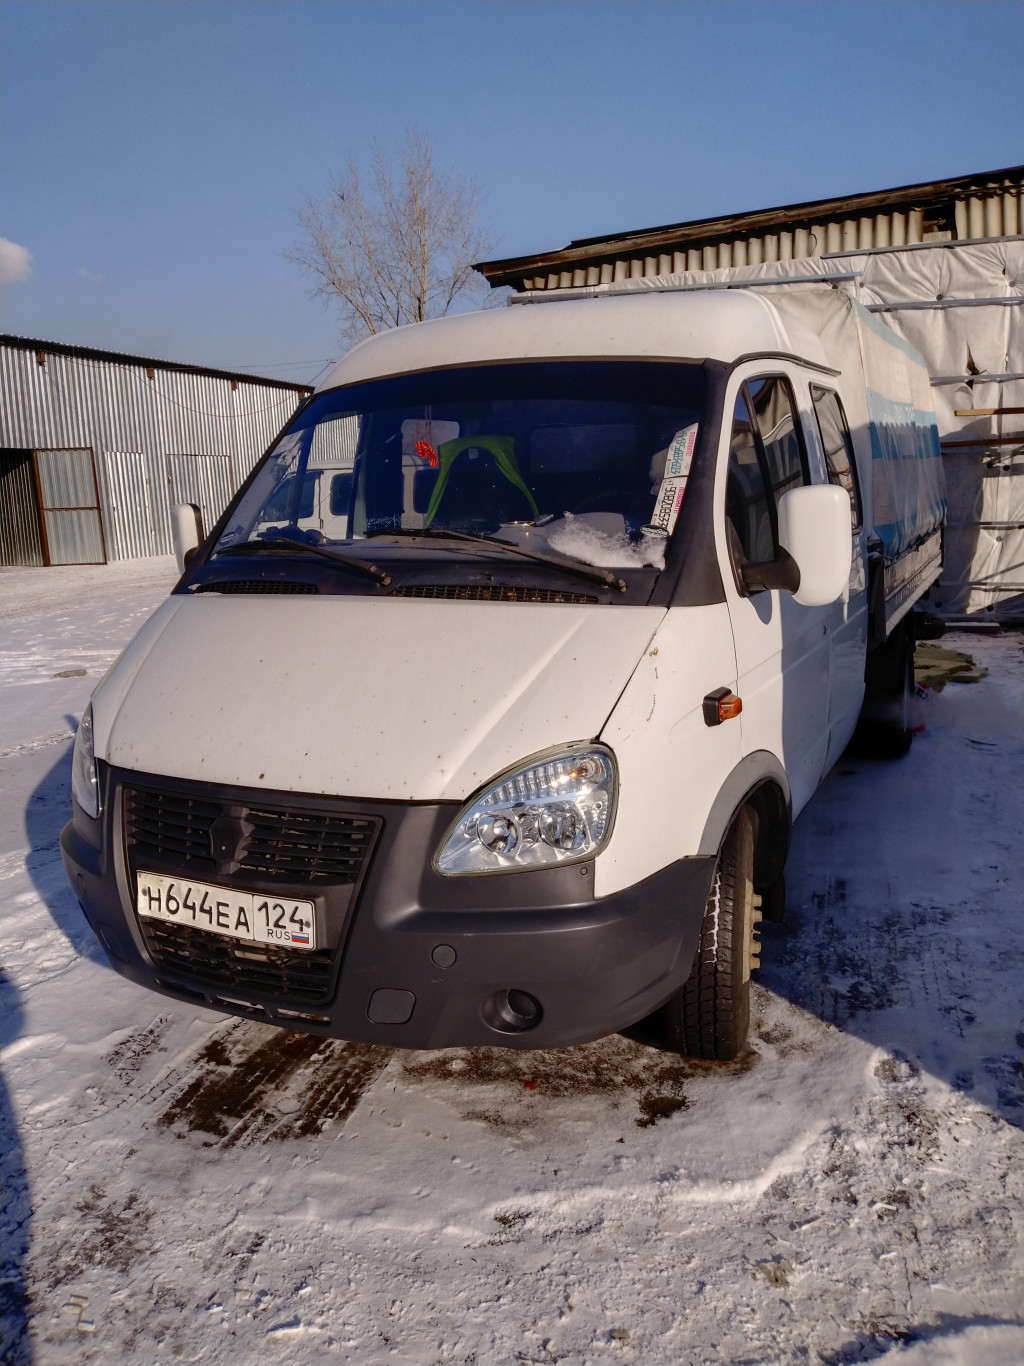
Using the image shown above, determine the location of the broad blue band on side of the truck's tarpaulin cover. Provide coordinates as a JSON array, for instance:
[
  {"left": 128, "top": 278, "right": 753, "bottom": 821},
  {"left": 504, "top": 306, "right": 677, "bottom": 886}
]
[{"left": 867, "top": 389, "right": 946, "bottom": 560}]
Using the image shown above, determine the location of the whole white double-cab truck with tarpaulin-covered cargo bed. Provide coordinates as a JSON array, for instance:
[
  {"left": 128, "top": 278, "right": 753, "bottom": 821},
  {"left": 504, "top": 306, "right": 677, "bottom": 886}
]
[{"left": 61, "top": 288, "right": 945, "bottom": 1059}]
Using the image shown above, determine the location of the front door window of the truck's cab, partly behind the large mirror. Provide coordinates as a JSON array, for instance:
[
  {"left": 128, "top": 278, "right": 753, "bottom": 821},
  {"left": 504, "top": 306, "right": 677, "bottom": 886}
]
[{"left": 725, "top": 374, "right": 808, "bottom": 564}]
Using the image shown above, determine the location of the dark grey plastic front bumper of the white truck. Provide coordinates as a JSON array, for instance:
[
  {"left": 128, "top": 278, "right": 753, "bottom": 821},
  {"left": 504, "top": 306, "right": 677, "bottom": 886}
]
[{"left": 60, "top": 766, "right": 714, "bottom": 1049}]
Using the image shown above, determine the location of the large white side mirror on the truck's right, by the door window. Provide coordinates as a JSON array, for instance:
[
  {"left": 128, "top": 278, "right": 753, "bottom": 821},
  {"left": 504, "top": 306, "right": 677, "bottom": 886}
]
[{"left": 778, "top": 484, "right": 853, "bottom": 607}]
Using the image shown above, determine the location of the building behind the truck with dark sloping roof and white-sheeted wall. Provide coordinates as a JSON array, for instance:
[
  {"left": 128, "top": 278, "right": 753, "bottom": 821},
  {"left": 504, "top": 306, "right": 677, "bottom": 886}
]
[{"left": 477, "top": 167, "right": 1024, "bottom": 615}]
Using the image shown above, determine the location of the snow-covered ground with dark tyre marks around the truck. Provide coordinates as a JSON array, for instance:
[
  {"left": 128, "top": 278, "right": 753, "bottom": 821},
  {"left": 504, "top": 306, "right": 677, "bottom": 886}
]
[{"left": 0, "top": 560, "right": 1024, "bottom": 1366}]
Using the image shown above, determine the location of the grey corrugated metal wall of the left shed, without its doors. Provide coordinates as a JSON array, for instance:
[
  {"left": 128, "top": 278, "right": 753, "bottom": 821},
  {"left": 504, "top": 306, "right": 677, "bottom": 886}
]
[{"left": 0, "top": 343, "right": 302, "bottom": 563}]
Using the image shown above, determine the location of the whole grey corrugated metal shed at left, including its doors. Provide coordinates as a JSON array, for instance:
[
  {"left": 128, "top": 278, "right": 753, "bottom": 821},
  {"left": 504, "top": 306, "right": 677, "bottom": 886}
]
[{"left": 0, "top": 336, "right": 310, "bottom": 564}]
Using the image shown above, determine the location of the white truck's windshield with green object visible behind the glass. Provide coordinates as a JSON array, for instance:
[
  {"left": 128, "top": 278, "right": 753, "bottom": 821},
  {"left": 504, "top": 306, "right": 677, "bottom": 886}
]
[{"left": 214, "top": 361, "right": 703, "bottom": 568}]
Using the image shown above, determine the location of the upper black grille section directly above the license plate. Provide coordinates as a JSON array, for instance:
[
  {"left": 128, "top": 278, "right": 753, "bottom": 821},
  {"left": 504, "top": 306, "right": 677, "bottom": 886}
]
[{"left": 124, "top": 787, "right": 380, "bottom": 885}]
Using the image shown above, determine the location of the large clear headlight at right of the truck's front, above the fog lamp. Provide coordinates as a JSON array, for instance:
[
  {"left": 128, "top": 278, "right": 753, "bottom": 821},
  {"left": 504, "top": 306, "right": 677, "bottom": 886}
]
[{"left": 434, "top": 744, "right": 617, "bottom": 877}]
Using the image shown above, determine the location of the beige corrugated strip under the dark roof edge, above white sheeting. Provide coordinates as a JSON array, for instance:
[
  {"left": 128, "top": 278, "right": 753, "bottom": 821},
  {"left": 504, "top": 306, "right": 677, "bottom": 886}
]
[{"left": 523, "top": 186, "right": 1021, "bottom": 290}]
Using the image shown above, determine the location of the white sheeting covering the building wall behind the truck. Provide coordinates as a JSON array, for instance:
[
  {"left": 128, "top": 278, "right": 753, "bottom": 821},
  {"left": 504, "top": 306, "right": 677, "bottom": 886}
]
[{"left": 554, "top": 238, "right": 1024, "bottom": 613}]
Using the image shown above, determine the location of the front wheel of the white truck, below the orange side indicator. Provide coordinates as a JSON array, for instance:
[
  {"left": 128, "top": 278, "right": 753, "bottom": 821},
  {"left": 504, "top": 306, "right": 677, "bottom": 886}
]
[{"left": 662, "top": 809, "right": 760, "bottom": 1061}]
